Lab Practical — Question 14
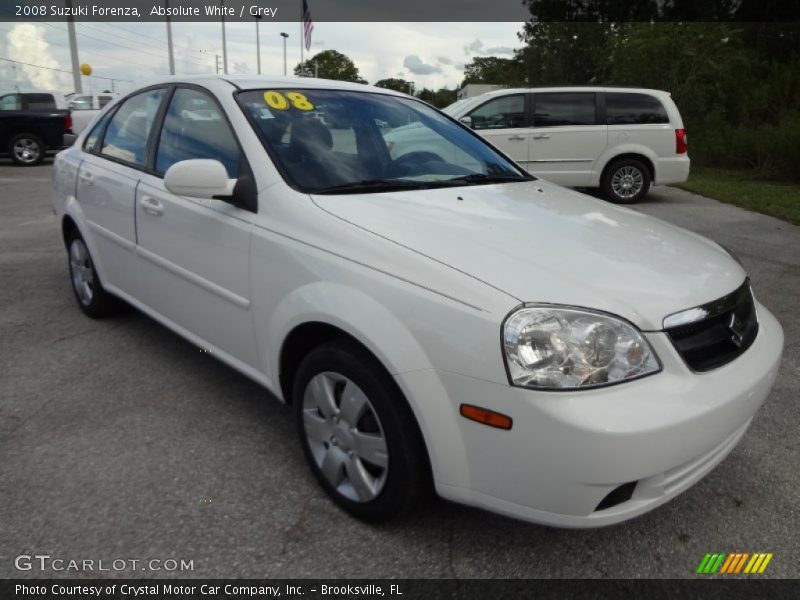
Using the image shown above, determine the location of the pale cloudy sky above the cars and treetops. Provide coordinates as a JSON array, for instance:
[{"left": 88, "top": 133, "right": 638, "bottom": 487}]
[{"left": 0, "top": 22, "right": 522, "bottom": 93}]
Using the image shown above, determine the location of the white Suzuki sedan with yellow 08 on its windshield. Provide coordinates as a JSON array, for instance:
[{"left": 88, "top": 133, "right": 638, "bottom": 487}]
[{"left": 54, "top": 77, "right": 783, "bottom": 527}]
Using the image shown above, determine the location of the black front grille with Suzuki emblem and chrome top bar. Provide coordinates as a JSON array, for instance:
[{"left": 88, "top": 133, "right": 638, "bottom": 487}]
[{"left": 664, "top": 280, "right": 758, "bottom": 372}]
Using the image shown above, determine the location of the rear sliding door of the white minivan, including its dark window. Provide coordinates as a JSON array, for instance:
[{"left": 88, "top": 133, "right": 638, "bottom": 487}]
[{"left": 530, "top": 91, "right": 608, "bottom": 186}]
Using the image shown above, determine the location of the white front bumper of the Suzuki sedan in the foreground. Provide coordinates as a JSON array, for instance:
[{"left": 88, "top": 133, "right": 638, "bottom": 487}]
[{"left": 397, "top": 305, "right": 783, "bottom": 527}]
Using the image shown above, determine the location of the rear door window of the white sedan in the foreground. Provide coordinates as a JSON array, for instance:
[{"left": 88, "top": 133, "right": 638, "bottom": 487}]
[{"left": 100, "top": 89, "right": 164, "bottom": 166}]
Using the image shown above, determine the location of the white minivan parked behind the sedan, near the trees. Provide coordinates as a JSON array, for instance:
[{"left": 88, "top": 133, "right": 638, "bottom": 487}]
[{"left": 434, "top": 87, "right": 689, "bottom": 204}]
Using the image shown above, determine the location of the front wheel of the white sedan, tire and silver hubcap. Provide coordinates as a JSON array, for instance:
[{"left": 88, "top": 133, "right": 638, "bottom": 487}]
[{"left": 292, "top": 341, "right": 431, "bottom": 523}]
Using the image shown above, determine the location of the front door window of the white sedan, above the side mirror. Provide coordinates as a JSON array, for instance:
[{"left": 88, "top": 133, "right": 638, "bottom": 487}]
[{"left": 156, "top": 88, "right": 241, "bottom": 178}]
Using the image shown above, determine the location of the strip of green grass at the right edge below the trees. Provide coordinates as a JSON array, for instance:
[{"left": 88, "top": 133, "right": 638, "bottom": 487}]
[{"left": 676, "top": 166, "right": 800, "bottom": 225}]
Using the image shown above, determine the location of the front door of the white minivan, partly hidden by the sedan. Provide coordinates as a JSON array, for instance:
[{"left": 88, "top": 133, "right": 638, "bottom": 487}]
[{"left": 467, "top": 93, "right": 531, "bottom": 168}]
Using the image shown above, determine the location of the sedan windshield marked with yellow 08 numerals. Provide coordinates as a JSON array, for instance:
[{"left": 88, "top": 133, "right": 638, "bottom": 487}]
[{"left": 237, "top": 89, "right": 533, "bottom": 194}]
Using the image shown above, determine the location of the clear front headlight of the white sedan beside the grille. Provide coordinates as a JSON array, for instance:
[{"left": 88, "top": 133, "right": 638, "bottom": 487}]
[{"left": 503, "top": 306, "right": 661, "bottom": 389}]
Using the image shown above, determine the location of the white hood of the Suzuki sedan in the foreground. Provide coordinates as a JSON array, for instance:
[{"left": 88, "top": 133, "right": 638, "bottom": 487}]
[{"left": 312, "top": 180, "right": 745, "bottom": 330}]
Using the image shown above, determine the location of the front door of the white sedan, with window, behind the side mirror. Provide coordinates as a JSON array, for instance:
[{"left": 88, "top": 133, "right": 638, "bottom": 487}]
[{"left": 131, "top": 86, "right": 258, "bottom": 367}]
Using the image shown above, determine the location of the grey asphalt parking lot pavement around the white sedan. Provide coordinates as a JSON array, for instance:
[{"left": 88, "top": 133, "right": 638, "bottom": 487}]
[{"left": 0, "top": 163, "right": 800, "bottom": 578}]
